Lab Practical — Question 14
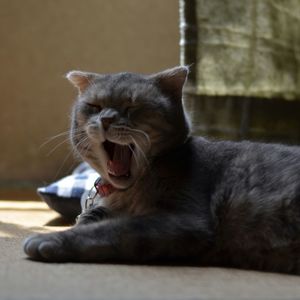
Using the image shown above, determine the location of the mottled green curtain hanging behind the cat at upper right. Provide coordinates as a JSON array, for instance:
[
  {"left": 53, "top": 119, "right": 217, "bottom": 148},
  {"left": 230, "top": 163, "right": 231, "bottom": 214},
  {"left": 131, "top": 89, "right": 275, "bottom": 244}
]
[{"left": 180, "top": 0, "right": 300, "bottom": 100}]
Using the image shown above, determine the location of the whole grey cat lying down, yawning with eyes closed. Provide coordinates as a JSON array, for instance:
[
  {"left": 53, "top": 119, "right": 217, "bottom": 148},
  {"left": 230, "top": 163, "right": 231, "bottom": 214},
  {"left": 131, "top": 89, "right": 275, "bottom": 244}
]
[{"left": 24, "top": 67, "right": 300, "bottom": 273}]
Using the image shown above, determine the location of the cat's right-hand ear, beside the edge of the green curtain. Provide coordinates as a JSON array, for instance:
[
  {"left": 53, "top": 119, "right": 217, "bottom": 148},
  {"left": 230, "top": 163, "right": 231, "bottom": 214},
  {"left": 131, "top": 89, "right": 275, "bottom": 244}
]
[{"left": 150, "top": 66, "right": 189, "bottom": 101}]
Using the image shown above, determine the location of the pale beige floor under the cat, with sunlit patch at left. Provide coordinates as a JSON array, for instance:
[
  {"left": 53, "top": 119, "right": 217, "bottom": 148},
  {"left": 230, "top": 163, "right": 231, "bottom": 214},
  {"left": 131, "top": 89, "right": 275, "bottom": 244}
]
[{"left": 0, "top": 201, "right": 300, "bottom": 300}]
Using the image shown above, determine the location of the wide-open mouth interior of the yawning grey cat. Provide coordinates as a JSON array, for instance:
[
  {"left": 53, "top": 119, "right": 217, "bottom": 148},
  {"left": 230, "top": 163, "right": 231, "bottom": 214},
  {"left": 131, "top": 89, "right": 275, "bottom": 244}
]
[{"left": 103, "top": 140, "right": 134, "bottom": 179}]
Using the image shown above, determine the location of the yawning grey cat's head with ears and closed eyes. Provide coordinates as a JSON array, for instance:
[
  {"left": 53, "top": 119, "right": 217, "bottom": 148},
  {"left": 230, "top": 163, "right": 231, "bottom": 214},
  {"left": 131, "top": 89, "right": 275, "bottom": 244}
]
[{"left": 67, "top": 67, "right": 189, "bottom": 189}]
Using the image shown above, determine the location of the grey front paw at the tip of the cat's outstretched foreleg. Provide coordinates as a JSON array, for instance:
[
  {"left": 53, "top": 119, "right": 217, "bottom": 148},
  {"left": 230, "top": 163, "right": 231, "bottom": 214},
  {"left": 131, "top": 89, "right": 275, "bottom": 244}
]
[{"left": 23, "top": 232, "right": 70, "bottom": 262}]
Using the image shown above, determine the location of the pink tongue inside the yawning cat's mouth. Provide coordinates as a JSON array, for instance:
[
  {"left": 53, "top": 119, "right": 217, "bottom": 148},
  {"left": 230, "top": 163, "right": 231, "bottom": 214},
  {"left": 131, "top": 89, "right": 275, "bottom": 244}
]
[{"left": 107, "top": 144, "right": 131, "bottom": 177}]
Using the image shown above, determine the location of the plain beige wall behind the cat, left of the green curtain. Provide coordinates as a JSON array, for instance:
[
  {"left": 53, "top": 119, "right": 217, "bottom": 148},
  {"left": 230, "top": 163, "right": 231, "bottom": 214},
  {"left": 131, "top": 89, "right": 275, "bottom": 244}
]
[{"left": 0, "top": 0, "right": 179, "bottom": 186}]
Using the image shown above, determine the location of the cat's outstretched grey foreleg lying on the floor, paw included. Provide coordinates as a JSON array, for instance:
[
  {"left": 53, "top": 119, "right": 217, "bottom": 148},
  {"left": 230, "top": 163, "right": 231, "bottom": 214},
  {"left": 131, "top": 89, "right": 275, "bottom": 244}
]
[{"left": 24, "top": 214, "right": 213, "bottom": 263}]
